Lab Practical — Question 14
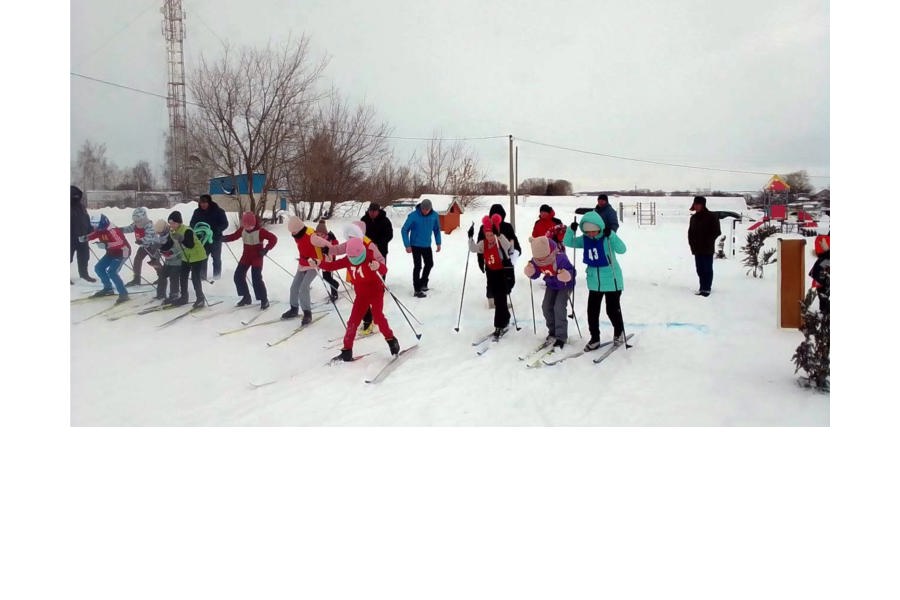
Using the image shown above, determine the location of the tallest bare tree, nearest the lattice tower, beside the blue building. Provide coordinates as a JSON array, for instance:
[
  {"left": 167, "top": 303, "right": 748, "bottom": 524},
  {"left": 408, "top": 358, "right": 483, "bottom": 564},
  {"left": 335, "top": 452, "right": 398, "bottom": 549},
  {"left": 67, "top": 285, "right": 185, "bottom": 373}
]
[{"left": 188, "top": 36, "right": 327, "bottom": 216}]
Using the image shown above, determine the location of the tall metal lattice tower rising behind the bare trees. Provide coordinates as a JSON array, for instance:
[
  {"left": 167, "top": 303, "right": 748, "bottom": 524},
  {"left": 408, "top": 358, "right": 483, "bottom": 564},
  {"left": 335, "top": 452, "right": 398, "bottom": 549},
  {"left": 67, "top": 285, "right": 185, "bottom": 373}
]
[{"left": 160, "top": 0, "right": 188, "bottom": 193}]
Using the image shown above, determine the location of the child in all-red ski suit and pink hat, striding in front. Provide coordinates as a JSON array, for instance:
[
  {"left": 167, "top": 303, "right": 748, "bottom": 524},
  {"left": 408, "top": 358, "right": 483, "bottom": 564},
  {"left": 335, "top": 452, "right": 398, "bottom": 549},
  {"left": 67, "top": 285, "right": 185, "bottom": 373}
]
[{"left": 310, "top": 238, "right": 400, "bottom": 362}]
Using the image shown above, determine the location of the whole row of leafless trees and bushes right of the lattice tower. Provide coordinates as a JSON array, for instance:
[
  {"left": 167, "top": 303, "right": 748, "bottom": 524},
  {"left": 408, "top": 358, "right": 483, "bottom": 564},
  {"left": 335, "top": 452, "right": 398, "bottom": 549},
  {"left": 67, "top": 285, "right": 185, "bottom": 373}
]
[{"left": 182, "top": 36, "right": 496, "bottom": 218}]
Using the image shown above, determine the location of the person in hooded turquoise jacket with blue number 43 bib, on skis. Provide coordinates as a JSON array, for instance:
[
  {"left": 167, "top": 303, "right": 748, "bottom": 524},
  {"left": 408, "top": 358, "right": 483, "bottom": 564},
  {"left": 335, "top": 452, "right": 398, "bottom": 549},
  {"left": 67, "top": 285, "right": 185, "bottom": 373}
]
[{"left": 566, "top": 211, "right": 626, "bottom": 352}]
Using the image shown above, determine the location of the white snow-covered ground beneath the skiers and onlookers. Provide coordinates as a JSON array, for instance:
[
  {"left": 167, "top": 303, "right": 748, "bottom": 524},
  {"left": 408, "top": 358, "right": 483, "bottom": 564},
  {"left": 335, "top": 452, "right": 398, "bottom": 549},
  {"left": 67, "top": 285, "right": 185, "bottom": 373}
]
[{"left": 70, "top": 197, "right": 830, "bottom": 426}]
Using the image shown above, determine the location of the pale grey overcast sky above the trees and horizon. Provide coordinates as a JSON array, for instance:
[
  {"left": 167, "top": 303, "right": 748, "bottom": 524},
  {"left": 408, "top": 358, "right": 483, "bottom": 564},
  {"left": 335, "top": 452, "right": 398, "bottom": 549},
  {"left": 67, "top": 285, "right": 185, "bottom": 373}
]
[{"left": 70, "top": 0, "right": 830, "bottom": 191}]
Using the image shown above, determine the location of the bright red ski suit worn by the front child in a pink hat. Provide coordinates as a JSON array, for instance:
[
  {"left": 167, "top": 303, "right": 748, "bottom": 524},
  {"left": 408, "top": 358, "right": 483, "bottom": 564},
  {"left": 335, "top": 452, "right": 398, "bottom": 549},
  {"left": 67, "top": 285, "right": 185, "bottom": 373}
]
[{"left": 319, "top": 248, "right": 394, "bottom": 350}]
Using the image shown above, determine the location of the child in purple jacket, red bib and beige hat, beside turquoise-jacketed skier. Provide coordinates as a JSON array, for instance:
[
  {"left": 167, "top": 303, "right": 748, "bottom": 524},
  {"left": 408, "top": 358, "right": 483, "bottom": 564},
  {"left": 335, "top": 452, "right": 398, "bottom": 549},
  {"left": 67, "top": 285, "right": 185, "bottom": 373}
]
[{"left": 525, "top": 235, "right": 575, "bottom": 348}]
